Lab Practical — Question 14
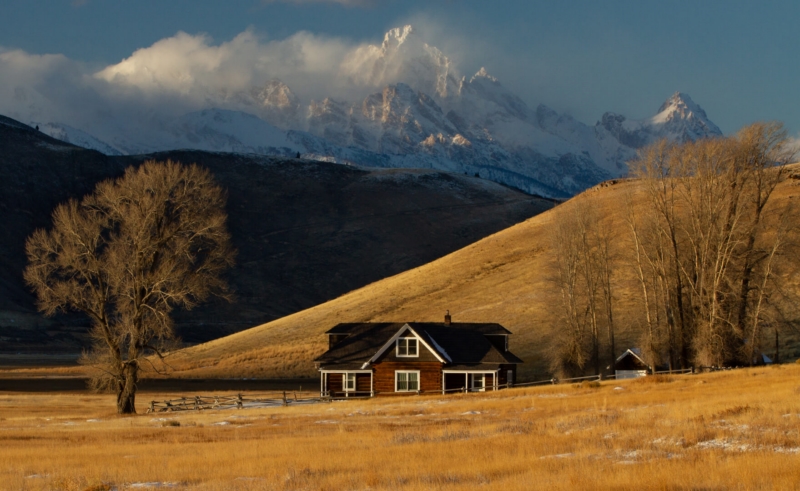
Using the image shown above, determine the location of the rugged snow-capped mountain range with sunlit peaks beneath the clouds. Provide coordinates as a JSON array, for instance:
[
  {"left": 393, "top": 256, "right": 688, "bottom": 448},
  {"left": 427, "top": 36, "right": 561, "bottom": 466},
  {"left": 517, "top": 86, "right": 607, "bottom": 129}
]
[{"left": 31, "top": 26, "right": 721, "bottom": 197}]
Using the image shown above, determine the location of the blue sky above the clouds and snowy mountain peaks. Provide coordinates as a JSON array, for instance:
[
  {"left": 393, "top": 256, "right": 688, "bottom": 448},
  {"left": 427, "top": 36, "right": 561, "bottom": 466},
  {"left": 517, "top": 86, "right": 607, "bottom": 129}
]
[{"left": 0, "top": 0, "right": 800, "bottom": 136}]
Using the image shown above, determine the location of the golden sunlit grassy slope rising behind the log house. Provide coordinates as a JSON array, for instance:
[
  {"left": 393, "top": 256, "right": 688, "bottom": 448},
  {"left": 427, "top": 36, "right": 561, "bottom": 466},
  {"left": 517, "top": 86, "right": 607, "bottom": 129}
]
[{"left": 169, "top": 169, "right": 800, "bottom": 379}]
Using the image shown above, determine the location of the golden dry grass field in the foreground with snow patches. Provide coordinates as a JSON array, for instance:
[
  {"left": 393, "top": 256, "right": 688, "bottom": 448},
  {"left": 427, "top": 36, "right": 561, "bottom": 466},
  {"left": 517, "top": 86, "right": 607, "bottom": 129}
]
[{"left": 0, "top": 364, "right": 800, "bottom": 490}]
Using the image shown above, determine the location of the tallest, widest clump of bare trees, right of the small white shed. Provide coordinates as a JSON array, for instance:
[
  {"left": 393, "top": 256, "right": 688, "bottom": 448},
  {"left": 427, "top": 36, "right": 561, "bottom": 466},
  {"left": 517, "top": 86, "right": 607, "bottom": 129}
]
[{"left": 629, "top": 123, "right": 792, "bottom": 366}]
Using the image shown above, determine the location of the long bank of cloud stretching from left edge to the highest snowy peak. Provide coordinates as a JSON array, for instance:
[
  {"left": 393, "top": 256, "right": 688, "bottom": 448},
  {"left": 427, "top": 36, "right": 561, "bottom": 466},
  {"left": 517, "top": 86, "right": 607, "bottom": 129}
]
[{"left": 0, "top": 24, "right": 476, "bottom": 143}]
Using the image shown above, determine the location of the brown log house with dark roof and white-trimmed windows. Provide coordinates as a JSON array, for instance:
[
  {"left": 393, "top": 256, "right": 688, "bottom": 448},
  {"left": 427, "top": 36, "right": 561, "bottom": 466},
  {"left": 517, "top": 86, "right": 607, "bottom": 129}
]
[{"left": 314, "top": 313, "right": 522, "bottom": 397}]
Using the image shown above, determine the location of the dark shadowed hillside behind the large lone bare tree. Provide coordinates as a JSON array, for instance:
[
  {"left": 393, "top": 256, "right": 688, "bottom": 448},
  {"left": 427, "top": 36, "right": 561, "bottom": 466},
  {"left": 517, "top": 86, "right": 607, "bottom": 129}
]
[{"left": 0, "top": 117, "right": 552, "bottom": 353}]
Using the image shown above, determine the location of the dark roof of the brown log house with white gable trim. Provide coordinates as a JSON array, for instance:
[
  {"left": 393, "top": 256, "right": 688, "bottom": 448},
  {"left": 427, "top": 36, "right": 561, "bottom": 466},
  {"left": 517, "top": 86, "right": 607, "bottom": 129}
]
[{"left": 314, "top": 322, "right": 522, "bottom": 365}]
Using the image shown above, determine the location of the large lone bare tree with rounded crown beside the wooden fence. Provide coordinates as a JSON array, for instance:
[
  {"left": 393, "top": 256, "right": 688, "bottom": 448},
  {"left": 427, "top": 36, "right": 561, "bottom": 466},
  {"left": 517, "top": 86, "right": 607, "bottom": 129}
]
[{"left": 25, "top": 161, "right": 235, "bottom": 413}]
